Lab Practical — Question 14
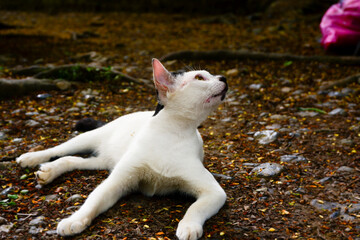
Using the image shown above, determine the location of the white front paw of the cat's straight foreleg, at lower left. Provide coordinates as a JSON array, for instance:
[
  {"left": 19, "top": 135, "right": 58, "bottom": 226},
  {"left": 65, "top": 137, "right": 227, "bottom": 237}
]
[{"left": 56, "top": 216, "right": 90, "bottom": 236}]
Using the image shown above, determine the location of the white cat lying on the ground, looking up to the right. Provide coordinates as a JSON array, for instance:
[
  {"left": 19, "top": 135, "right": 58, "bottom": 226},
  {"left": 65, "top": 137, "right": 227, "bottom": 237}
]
[{"left": 17, "top": 59, "right": 228, "bottom": 240}]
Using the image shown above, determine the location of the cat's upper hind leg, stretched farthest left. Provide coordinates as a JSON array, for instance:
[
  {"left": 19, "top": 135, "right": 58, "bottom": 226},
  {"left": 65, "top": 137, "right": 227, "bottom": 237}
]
[{"left": 16, "top": 129, "right": 101, "bottom": 167}]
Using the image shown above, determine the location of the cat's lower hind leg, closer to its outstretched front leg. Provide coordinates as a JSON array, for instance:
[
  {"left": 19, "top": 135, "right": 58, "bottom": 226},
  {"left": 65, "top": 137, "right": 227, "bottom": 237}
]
[{"left": 35, "top": 156, "right": 112, "bottom": 185}]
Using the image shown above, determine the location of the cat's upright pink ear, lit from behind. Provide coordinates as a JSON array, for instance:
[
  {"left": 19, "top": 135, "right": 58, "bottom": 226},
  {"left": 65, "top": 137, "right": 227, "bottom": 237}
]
[{"left": 152, "top": 58, "right": 175, "bottom": 104}]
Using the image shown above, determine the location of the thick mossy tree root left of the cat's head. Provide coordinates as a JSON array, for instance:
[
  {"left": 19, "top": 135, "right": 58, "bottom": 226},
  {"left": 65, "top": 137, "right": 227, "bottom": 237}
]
[{"left": 0, "top": 64, "right": 153, "bottom": 98}]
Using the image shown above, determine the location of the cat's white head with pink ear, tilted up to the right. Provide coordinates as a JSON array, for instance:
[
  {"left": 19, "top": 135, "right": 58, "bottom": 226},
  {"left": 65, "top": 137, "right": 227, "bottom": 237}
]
[{"left": 152, "top": 59, "right": 228, "bottom": 121}]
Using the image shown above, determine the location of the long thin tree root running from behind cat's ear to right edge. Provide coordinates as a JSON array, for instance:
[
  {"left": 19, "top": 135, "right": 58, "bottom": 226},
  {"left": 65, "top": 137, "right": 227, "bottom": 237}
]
[{"left": 160, "top": 50, "right": 360, "bottom": 65}]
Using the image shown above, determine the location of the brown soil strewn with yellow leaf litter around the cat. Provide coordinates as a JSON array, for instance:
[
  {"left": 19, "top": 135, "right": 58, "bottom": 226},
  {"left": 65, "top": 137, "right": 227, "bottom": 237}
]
[{"left": 0, "top": 12, "right": 360, "bottom": 239}]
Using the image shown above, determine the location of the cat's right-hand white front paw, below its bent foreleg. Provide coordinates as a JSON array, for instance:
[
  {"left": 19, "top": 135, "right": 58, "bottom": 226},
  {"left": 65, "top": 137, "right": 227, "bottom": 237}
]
[{"left": 176, "top": 220, "right": 203, "bottom": 240}]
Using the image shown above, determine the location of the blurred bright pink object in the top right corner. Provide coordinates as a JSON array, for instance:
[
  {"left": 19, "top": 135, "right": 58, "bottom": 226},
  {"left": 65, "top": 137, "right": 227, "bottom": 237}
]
[{"left": 320, "top": 0, "right": 360, "bottom": 50}]
